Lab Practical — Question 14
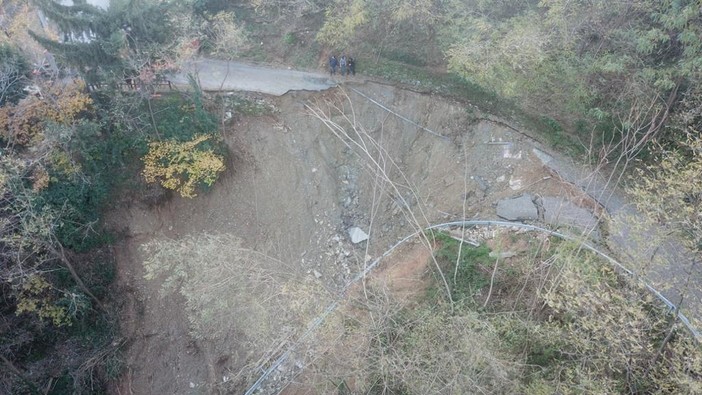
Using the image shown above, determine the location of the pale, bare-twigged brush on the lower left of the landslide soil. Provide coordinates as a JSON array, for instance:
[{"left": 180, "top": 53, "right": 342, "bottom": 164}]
[{"left": 142, "top": 234, "right": 329, "bottom": 390}]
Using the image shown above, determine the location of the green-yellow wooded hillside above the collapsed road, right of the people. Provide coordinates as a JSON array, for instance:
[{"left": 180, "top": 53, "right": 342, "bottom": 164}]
[{"left": 317, "top": 0, "right": 702, "bottom": 158}]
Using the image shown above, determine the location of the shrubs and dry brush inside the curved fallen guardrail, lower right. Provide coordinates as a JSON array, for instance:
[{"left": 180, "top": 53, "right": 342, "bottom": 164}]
[{"left": 314, "top": 230, "right": 702, "bottom": 395}]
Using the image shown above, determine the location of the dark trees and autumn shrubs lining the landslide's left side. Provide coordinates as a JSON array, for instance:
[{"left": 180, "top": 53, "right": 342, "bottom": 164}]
[{"left": 0, "top": 1, "right": 226, "bottom": 394}]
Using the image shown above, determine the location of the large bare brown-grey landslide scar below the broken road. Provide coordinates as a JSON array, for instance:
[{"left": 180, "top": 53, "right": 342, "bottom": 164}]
[{"left": 111, "top": 82, "right": 592, "bottom": 394}]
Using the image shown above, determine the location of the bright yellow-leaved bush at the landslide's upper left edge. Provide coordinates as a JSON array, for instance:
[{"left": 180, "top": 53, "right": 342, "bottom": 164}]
[{"left": 142, "top": 135, "right": 225, "bottom": 198}]
